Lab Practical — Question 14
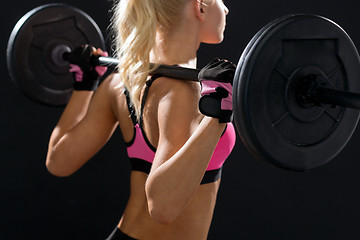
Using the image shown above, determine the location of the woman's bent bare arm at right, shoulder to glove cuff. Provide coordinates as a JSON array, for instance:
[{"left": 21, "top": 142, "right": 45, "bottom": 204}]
[{"left": 145, "top": 79, "right": 224, "bottom": 224}]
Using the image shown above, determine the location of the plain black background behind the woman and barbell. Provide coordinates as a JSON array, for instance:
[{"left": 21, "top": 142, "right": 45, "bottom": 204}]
[{"left": 0, "top": 0, "right": 360, "bottom": 240}]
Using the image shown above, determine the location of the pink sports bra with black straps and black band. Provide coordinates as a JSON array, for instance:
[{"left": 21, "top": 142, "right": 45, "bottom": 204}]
[{"left": 124, "top": 75, "right": 236, "bottom": 184}]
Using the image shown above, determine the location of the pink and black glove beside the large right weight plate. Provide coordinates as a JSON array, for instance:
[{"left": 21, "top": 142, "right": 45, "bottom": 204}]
[{"left": 198, "top": 59, "right": 236, "bottom": 123}]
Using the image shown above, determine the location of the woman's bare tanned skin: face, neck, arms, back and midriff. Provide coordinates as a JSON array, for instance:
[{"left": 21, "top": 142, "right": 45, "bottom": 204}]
[{"left": 46, "top": 0, "right": 228, "bottom": 240}]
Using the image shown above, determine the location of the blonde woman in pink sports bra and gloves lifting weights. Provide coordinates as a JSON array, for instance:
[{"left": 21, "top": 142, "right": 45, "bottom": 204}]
[{"left": 46, "top": 0, "right": 235, "bottom": 240}]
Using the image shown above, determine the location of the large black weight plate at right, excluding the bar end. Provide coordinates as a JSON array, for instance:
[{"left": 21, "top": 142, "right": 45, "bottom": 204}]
[{"left": 233, "top": 15, "right": 360, "bottom": 171}]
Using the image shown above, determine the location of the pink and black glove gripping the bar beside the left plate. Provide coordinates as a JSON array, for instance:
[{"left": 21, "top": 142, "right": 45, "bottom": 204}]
[{"left": 69, "top": 44, "right": 108, "bottom": 91}]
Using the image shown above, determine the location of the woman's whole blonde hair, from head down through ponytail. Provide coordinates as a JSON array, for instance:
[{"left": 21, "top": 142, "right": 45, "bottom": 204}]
[{"left": 112, "top": 0, "right": 188, "bottom": 120}]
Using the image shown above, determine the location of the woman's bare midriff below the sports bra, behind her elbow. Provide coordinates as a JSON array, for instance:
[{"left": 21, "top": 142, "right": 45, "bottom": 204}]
[{"left": 118, "top": 171, "right": 220, "bottom": 240}]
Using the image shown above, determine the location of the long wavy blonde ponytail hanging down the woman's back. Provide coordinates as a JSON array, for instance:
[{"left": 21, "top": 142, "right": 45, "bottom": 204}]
[{"left": 113, "top": 0, "right": 156, "bottom": 120}]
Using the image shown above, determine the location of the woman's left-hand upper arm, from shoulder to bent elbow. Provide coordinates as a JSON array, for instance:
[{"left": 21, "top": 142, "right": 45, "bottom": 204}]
[{"left": 47, "top": 74, "right": 117, "bottom": 176}]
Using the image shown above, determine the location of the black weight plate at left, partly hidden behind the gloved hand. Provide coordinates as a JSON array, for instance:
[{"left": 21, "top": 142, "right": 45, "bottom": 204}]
[{"left": 7, "top": 4, "right": 105, "bottom": 106}]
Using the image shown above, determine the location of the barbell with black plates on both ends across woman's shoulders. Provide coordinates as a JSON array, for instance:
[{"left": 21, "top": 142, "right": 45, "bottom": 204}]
[{"left": 7, "top": 4, "right": 360, "bottom": 171}]
